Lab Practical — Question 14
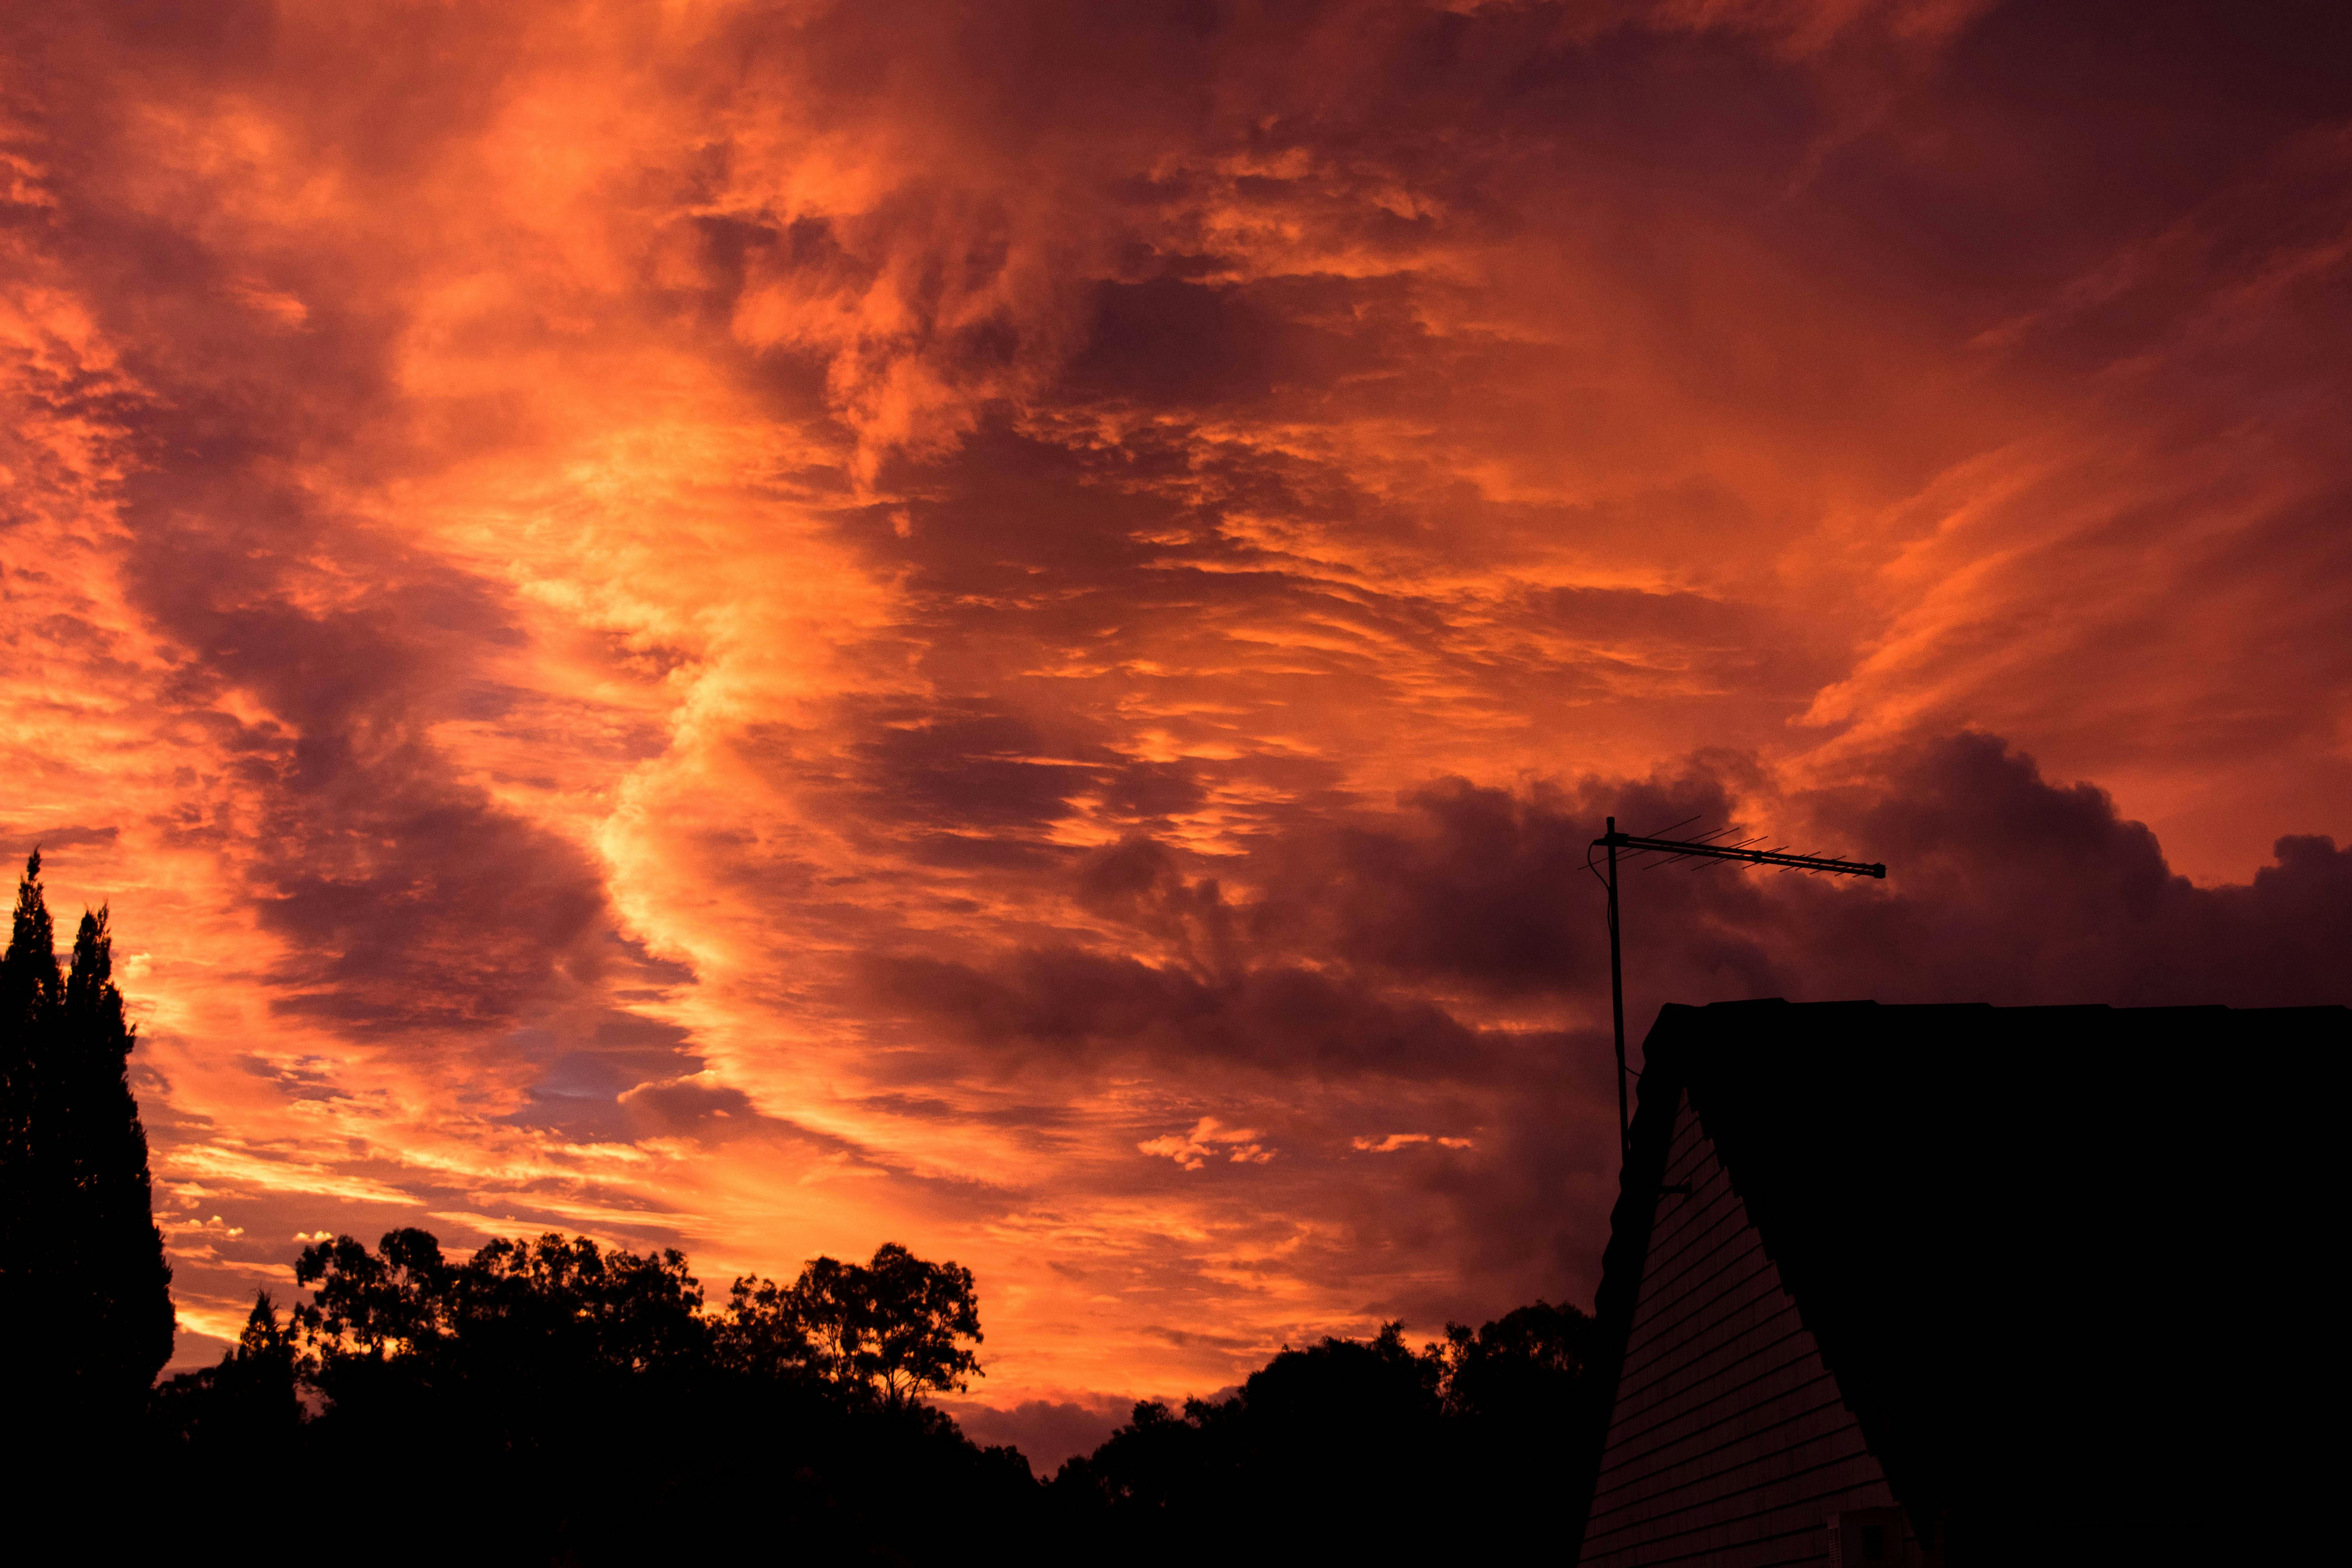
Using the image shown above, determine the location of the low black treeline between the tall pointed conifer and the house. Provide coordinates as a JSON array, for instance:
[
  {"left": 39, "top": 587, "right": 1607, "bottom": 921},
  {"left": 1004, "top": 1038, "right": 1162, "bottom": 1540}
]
[{"left": 151, "top": 1229, "right": 1599, "bottom": 1563}]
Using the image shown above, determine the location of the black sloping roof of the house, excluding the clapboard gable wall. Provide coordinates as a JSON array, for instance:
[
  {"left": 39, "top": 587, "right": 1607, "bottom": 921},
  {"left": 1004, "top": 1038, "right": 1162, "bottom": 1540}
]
[{"left": 1597, "top": 999, "right": 2352, "bottom": 1544}]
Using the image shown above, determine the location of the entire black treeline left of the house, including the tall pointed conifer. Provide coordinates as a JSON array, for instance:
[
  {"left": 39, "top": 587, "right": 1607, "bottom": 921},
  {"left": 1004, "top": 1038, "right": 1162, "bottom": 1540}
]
[{"left": 0, "top": 853, "right": 1602, "bottom": 1566}]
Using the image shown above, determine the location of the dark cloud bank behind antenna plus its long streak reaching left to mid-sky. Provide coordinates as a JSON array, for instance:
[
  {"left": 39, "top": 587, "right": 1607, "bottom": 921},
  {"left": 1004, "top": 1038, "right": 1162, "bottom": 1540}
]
[{"left": 868, "top": 719, "right": 2352, "bottom": 1105}]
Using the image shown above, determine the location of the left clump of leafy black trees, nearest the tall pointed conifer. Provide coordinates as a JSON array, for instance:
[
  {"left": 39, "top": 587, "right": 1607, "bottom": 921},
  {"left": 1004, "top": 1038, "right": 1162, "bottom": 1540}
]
[{"left": 158, "top": 1229, "right": 1021, "bottom": 1563}]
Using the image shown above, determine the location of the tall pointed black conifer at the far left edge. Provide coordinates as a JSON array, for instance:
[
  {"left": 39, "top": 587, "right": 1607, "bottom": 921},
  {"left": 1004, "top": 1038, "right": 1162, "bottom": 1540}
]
[{"left": 0, "top": 853, "right": 172, "bottom": 1425}]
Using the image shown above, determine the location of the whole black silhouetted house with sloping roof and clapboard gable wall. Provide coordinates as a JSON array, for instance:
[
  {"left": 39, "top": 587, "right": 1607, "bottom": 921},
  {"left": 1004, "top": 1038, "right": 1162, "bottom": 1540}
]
[{"left": 1581, "top": 999, "right": 2352, "bottom": 1568}]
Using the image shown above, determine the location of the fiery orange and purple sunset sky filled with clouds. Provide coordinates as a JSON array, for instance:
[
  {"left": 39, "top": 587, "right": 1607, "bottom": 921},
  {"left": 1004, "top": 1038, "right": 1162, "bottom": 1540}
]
[{"left": 0, "top": 0, "right": 2352, "bottom": 1462}]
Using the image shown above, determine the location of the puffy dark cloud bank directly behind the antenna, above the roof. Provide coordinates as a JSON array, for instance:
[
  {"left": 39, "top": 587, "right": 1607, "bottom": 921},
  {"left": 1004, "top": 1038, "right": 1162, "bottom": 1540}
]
[{"left": 1232, "top": 736, "right": 2352, "bottom": 1016}]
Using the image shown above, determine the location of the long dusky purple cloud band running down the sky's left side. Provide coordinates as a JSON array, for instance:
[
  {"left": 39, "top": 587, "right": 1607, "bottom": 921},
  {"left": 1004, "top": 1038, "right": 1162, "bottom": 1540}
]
[{"left": 2, "top": 9, "right": 654, "bottom": 1053}]
